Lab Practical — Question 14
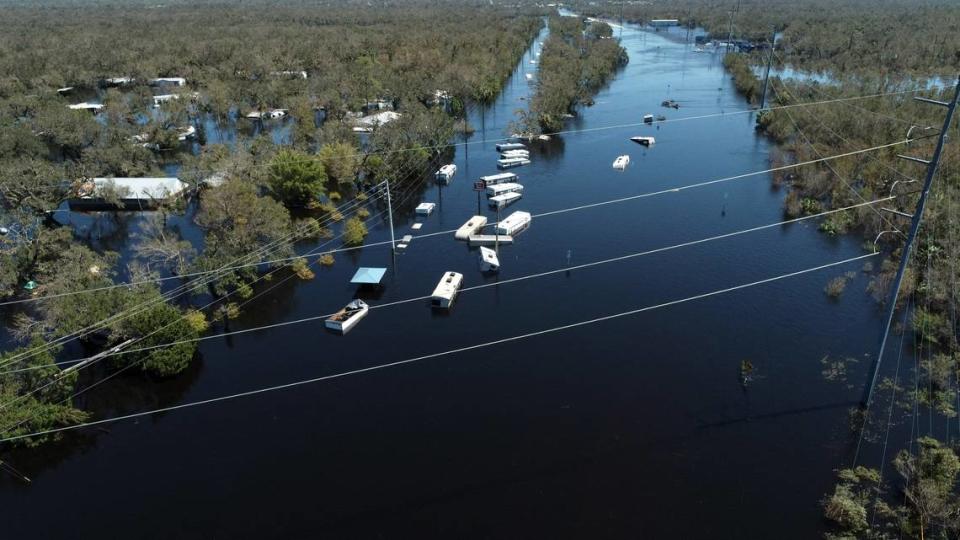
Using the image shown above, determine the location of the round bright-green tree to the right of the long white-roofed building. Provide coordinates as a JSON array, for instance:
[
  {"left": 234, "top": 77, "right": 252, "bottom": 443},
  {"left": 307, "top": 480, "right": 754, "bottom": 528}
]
[{"left": 269, "top": 150, "right": 327, "bottom": 206}]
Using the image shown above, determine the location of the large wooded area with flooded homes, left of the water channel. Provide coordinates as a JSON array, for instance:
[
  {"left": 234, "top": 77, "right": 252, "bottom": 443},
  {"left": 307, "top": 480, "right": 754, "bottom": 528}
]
[{"left": 0, "top": 0, "right": 542, "bottom": 444}]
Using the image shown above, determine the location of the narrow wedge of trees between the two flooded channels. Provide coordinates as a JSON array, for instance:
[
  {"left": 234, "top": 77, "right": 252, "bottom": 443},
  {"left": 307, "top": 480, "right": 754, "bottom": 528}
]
[{"left": 522, "top": 16, "right": 628, "bottom": 133}]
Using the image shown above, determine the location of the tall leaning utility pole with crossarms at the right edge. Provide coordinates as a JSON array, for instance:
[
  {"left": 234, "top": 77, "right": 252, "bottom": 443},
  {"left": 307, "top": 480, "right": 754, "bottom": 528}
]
[{"left": 863, "top": 77, "right": 960, "bottom": 409}]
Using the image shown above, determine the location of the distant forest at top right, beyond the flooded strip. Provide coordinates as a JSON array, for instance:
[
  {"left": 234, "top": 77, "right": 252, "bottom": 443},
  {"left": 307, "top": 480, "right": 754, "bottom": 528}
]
[{"left": 575, "top": 0, "right": 960, "bottom": 79}]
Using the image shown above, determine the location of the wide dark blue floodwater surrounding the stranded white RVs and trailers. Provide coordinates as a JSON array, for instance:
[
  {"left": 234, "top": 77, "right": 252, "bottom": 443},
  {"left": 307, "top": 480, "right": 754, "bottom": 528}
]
[{"left": 0, "top": 14, "right": 928, "bottom": 538}]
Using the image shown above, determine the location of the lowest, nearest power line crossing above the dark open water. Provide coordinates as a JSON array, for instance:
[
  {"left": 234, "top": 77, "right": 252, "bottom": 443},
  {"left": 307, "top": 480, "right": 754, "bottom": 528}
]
[{"left": 0, "top": 252, "right": 879, "bottom": 443}]
